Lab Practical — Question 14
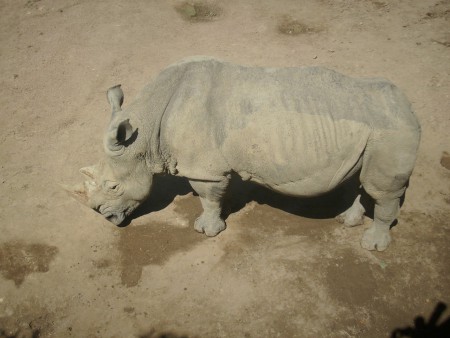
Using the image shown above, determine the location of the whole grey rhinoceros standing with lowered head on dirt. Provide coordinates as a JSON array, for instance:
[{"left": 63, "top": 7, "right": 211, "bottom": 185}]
[{"left": 67, "top": 57, "right": 420, "bottom": 251}]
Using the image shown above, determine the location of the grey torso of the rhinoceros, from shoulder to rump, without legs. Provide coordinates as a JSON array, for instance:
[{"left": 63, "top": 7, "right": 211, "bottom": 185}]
[{"left": 161, "top": 59, "right": 417, "bottom": 195}]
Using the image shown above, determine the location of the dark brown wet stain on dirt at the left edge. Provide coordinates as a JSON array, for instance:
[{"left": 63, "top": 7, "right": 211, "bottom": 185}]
[{"left": 0, "top": 241, "right": 58, "bottom": 286}]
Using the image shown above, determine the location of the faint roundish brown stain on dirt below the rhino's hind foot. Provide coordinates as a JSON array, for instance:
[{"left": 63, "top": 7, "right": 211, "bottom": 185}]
[{"left": 326, "top": 250, "right": 377, "bottom": 307}]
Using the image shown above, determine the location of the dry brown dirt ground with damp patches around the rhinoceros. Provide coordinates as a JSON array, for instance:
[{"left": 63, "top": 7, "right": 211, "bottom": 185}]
[{"left": 0, "top": 0, "right": 450, "bottom": 338}]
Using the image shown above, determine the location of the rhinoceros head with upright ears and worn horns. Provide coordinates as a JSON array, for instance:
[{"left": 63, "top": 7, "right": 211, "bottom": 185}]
[{"left": 66, "top": 86, "right": 152, "bottom": 225}]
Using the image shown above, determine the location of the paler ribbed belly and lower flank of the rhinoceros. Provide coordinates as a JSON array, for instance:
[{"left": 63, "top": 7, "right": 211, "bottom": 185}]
[{"left": 221, "top": 112, "right": 370, "bottom": 196}]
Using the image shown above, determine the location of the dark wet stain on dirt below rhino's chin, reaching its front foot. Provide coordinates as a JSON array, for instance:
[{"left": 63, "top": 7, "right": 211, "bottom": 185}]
[{"left": 119, "top": 196, "right": 207, "bottom": 287}]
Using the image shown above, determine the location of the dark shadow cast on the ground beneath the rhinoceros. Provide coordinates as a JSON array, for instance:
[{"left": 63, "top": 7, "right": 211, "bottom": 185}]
[{"left": 132, "top": 175, "right": 373, "bottom": 225}]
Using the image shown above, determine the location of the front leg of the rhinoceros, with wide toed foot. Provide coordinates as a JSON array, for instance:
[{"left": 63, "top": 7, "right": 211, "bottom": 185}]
[{"left": 189, "top": 178, "right": 229, "bottom": 237}]
